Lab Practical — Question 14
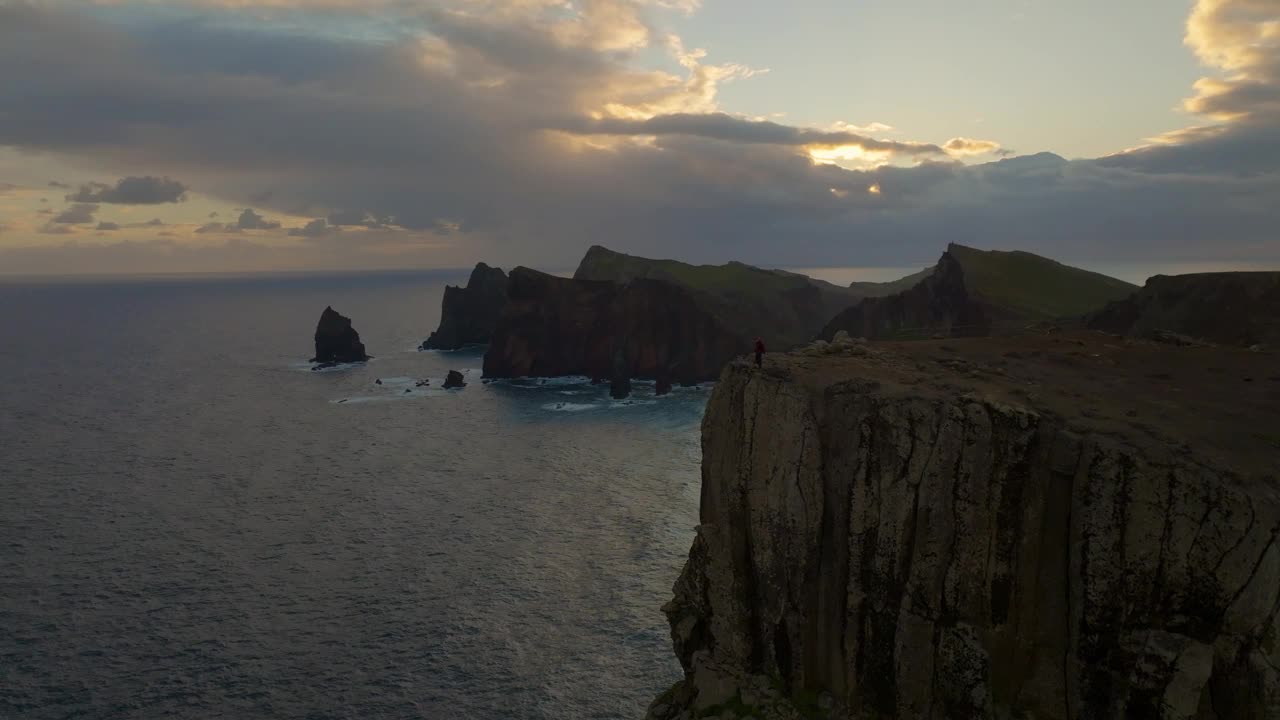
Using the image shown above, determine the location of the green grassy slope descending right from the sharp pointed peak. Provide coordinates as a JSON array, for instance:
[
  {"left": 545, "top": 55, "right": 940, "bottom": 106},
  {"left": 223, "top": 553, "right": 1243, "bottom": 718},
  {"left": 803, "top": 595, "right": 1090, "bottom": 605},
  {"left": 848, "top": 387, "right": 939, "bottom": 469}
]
[{"left": 947, "top": 245, "right": 1138, "bottom": 319}]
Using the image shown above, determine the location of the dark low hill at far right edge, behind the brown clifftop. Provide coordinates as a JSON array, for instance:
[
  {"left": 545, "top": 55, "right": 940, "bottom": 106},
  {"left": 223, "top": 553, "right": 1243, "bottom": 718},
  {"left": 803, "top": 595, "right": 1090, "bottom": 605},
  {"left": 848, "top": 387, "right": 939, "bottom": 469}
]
[{"left": 1088, "top": 273, "right": 1280, "bottom": 346}]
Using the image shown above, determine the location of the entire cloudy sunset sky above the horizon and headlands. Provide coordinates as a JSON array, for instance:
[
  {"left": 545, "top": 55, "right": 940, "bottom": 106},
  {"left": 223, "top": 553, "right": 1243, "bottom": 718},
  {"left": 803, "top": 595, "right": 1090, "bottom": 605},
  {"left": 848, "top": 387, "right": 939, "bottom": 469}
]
[{"left": 0, "top": 0, "right": 1280, "bottom": 274}]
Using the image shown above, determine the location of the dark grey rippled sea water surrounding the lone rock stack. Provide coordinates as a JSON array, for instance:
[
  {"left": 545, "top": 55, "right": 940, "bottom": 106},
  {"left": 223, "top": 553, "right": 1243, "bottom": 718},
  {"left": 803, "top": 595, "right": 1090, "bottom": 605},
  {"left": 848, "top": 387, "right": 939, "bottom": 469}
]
[{"left": 0, "top": 273, "right": 708, "bottom": 719}]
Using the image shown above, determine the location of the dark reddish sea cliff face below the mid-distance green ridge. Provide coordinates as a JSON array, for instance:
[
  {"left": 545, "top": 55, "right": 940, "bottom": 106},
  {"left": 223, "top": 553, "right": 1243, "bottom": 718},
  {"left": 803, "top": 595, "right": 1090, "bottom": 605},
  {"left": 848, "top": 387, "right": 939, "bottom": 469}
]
[{"left": 484, "top": 268, "right": 750, "bottom": 383}]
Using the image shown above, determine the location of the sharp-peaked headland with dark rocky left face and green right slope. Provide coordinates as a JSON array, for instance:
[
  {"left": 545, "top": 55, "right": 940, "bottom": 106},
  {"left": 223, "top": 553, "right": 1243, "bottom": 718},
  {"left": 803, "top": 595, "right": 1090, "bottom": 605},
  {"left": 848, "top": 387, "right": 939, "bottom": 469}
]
[{"left": 819, "top": 243, "right": 1137, "bottom": 340}]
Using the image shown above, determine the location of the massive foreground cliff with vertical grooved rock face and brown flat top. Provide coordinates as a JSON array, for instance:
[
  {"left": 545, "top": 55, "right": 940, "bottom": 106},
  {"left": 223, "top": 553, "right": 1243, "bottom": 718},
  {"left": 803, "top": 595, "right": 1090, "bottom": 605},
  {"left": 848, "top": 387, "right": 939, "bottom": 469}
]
[{"left": 649, "top": 334, "right": 1280, "bottom": 720}]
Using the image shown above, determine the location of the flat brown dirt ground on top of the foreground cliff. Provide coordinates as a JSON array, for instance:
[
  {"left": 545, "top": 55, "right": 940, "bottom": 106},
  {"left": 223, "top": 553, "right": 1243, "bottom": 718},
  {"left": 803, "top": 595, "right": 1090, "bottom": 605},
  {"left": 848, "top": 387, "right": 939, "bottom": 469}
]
[{"left": 768, "top": 331, "right": 1280, "bottom": 482}]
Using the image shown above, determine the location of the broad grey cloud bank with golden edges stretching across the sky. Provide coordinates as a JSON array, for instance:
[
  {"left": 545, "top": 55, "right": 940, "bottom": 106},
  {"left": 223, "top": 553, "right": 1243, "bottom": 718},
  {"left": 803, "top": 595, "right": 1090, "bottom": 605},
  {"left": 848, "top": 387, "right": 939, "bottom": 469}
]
[{"left": 0, "top": 0, "right": 1280, "bottom": 266}]
